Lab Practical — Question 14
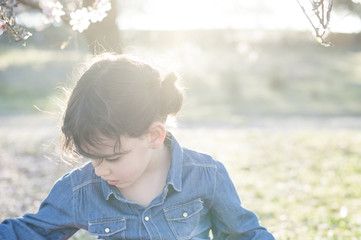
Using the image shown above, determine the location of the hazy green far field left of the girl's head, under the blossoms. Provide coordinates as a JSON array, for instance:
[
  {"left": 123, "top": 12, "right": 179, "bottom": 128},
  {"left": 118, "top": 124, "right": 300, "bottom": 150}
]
[{"left": 0, "top": 45, "right": 88, "bottom": 114}]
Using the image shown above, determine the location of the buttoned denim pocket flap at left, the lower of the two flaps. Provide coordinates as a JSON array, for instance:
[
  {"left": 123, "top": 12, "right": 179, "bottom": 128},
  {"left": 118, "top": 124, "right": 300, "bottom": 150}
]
[{"left": 88, "top": 218, "right": 127, "bottom": 236}]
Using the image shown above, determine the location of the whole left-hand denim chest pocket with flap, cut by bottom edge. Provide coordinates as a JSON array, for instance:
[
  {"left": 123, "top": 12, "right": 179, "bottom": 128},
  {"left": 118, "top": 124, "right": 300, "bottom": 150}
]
[{"left": 88, "top": 218, "right": 127, "bottom": 240}]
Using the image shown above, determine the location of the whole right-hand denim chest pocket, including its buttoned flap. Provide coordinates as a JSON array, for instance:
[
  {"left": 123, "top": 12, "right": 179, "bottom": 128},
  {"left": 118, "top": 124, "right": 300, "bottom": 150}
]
[{"left": 164, "top": 199, "right": 203, "bottom": 240}]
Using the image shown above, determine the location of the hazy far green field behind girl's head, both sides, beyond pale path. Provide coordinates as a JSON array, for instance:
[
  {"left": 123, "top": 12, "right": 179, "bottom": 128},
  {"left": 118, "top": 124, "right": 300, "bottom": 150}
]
[{"left": 0, "top": 30, "right": 361, "bottom": 118}]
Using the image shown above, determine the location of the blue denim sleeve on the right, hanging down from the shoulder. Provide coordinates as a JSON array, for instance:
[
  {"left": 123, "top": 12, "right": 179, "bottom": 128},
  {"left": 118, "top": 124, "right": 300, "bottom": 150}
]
[{"left": 211, "top": 163, "right": 274, "bottom": 240}]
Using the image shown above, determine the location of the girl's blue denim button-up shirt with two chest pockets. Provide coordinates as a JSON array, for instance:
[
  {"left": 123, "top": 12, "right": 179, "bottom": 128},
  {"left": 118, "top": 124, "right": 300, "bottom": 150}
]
[{"left": 0, "top": 134, "right": 274, "bottom": 240}]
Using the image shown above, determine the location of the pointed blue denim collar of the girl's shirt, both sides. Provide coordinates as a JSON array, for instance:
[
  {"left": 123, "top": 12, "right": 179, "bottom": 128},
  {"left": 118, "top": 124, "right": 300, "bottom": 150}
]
[{"left": 100, "top": 134, "right": 183, "bottom": 200}]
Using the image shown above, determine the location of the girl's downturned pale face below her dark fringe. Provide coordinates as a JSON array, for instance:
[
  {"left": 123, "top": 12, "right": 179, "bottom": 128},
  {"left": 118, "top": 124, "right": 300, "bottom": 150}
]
[{"left": 82, "top": 136, "right": 153, "bottom": 189}]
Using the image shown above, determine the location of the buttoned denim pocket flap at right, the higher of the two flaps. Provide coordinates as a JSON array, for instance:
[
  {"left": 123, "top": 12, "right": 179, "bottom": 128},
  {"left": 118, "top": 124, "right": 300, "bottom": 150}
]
[{"left": 164, "top": 199, "right": 203, "bottom": 221}]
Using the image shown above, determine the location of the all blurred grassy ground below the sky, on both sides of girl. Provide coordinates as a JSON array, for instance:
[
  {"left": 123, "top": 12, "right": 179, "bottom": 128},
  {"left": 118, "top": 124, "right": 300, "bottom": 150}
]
[{"left": 0, "top": 30, "right": 361, "bottom": 240}]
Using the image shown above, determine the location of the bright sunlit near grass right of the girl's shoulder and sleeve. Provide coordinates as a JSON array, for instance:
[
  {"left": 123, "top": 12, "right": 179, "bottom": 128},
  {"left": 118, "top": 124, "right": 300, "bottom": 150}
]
[{"left": 176, "top": 129, "right": 361, "bottom": 239}]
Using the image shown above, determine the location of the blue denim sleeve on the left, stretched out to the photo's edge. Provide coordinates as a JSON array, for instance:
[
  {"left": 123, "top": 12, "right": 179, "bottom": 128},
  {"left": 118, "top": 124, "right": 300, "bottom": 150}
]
[{"left": 0, "top": 172, "right": 78, "bottom": 240}]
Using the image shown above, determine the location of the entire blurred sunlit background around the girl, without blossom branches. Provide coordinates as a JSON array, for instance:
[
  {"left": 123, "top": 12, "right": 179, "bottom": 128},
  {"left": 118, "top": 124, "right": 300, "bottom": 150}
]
[{"left": 0, "top": 0, "right": 361, "bottom": 239}]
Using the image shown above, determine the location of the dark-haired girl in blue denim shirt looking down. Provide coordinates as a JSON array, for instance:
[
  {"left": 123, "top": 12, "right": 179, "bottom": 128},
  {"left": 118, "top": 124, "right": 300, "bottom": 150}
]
[{"left": 0, "top": 54, "right": 274, "bottom": 240}]
